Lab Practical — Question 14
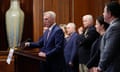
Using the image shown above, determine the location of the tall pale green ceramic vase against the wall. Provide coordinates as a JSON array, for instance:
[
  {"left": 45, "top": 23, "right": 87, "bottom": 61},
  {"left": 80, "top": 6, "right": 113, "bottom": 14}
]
[{"left": 5, "top": 0, "right": 24, "bottom": 48}]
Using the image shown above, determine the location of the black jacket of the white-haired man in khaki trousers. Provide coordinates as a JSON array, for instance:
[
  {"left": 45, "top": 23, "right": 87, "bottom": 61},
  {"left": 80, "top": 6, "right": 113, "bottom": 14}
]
[{"left": 77, "top": 26, "right": 99, "bottom": 64}]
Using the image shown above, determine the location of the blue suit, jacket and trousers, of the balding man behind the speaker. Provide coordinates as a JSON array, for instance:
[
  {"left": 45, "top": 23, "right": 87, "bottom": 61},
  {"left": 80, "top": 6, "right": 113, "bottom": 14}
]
[{"left": 64, "top": 32, "right": 79, "bottom": 72}]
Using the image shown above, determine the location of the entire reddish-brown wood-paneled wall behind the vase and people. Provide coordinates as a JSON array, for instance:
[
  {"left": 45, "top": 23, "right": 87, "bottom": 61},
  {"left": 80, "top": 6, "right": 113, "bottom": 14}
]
[{"left": 0, "top": 0, "right": 120, "bottom": 50}]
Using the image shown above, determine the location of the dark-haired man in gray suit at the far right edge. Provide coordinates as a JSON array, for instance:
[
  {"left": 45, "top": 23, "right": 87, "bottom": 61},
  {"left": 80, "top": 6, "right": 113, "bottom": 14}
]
[{"left": 95, "top": 2, "right": 120, "bottom": 72}]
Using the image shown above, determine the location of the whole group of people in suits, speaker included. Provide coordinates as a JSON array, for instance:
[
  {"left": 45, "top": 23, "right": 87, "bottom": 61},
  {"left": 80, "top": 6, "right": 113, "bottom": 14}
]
[{"left": 25, "top": 2, "right": 120, "bottom": 72}]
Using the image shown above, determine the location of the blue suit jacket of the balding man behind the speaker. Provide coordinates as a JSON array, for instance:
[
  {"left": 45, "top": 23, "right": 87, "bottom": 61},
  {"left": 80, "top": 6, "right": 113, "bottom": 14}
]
[{"left": 64, "top": 32, "right": 78, "bottom": 64}]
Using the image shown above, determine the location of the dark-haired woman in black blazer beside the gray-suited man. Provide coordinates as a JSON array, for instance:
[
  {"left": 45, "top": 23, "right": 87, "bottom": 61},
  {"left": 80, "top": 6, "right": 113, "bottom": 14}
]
[{"left": 87, "top": 16, "right": 109, "bottom": 72}]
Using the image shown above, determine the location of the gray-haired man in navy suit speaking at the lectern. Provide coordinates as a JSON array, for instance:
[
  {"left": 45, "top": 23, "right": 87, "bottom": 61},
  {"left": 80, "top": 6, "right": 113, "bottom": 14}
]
[{"left": 25, "top": 11, "right": 65, "bottom": 72}]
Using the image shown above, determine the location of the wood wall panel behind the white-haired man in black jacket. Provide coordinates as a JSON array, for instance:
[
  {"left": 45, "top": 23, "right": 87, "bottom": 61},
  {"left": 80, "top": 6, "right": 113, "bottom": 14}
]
[{"left": 74, "top": 0, "right": 111, "bottom": 27}]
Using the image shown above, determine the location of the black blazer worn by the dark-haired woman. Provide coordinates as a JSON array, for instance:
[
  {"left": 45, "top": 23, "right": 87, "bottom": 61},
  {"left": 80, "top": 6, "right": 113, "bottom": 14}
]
[{"left": 87, "top": 36, "right": 102, "bottom": 68}]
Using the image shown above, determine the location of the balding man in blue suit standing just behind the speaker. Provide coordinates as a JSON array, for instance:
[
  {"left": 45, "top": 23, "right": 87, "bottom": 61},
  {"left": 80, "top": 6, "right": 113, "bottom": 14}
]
[{"left": 64, "top": 23, "right": 79, "bottom": 72}]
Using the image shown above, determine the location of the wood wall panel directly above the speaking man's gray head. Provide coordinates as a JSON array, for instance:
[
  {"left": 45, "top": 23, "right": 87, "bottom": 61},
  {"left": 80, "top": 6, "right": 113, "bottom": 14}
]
[{"left": 44, "top": 0, "right": 72, "bottom": 24}]
